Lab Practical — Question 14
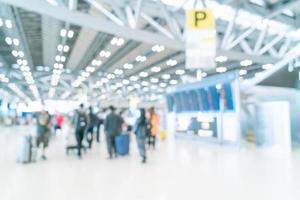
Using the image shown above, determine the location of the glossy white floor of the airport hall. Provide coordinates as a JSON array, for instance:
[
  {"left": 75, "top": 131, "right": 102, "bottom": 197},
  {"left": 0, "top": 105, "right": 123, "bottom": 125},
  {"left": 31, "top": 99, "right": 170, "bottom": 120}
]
[{"left": 0, "top": 127, "right": 300, "bottom": 200}]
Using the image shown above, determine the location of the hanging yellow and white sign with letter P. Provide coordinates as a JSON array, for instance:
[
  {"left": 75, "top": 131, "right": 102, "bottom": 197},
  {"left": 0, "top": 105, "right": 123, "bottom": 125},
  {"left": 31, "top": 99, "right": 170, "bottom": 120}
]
[{"left": 186, "top": 9, "right": 217, "bottom": 70}]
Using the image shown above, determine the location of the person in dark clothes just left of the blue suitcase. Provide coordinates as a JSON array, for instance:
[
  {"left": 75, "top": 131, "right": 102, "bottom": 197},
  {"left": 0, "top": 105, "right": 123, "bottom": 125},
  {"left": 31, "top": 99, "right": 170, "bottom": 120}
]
[{"left": 104, "top": 106, "right": 123, "bottom": 159}]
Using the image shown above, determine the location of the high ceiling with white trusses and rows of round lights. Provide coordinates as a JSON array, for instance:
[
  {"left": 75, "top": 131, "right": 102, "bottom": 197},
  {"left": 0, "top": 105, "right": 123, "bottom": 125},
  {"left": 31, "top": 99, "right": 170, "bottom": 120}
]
[{"left": 0, "top": 0, "right": 300, "bottom": 104}]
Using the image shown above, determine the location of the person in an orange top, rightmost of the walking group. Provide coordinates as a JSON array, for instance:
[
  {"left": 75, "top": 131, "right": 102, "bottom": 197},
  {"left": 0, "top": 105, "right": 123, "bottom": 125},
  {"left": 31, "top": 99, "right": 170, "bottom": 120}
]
[{"left": 148, "top": 107, "right": 159, "bottom": 149}]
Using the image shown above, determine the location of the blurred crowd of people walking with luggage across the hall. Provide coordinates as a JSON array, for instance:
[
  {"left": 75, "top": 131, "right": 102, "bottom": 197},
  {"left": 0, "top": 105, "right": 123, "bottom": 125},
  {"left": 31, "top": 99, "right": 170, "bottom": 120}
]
[{"left": 35, "top": 104, "right": 159, "bottom": 163}]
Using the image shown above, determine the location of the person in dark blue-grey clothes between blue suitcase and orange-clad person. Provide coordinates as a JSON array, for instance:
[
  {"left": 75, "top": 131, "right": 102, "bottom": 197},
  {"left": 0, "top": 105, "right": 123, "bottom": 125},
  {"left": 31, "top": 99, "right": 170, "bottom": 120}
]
[{"left": 134, "top": 108, "right": 148, "bottom": 163}]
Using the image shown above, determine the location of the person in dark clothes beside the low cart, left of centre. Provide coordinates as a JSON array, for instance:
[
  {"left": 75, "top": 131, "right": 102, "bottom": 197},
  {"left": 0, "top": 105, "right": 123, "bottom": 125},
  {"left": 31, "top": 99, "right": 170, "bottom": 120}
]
[{"left": 73, "top": 104, "right": 89, "bottom": 158}]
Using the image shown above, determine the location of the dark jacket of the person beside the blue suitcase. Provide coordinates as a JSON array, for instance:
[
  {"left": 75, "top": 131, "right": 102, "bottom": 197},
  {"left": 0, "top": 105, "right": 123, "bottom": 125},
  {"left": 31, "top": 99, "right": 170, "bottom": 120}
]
[{"left": 104, "top": 112, "right": 124, "bottom": 136}]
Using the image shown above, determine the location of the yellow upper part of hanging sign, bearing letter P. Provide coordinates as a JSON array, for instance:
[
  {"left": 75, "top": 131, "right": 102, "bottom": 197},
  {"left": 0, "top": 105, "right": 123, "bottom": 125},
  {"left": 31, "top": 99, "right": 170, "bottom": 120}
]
[{"left": 186, "top": 9, "right": 216, "bottom": 29}]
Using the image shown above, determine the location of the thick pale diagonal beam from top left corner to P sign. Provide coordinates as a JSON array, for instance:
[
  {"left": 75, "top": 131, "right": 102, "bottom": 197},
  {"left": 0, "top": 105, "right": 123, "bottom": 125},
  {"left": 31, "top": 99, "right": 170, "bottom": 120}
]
[{"left": 0, "top": 0, "right": 184, "bottom": 49}]
